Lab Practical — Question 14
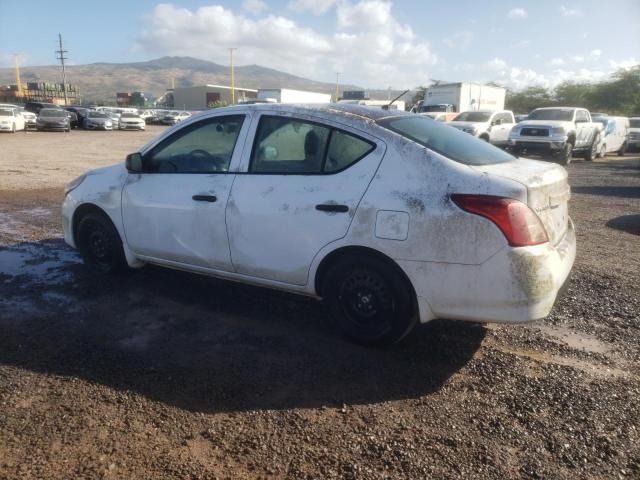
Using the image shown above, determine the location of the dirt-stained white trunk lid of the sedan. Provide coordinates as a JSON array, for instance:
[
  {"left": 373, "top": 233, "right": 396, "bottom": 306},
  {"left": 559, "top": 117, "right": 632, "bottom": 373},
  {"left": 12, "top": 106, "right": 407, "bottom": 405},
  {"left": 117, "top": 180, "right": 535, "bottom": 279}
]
[{"left": 472, "top": 158, "right": 571, "bottom": 245}]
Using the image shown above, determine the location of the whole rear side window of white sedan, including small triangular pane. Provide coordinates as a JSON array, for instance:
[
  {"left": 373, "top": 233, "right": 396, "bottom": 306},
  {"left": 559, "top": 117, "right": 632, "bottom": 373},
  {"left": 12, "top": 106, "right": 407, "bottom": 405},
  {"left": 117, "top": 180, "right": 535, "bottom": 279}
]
[{"left": 249, "top": 116, "right": 375, "bottom": 174}]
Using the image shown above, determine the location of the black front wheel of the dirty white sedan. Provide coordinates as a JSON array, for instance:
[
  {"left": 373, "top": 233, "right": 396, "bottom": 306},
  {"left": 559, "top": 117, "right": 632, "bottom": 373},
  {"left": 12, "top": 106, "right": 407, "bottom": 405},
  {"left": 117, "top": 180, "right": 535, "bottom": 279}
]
[{"left": 76, "top": 213, "right": 126, "bottom": 274}]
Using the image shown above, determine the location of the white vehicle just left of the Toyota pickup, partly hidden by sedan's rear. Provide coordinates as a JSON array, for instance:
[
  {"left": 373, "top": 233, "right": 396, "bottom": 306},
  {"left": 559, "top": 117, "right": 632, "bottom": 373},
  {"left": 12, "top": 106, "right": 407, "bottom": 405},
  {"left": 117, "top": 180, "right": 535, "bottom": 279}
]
[{"left": 448, "top": 110, "right": 516, "bottom": 147}]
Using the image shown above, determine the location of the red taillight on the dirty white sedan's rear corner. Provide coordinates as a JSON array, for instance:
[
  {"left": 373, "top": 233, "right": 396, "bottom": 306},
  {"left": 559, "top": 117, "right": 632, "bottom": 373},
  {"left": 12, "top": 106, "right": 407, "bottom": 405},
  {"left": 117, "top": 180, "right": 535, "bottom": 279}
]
[{"left": 451, "top": 193, "right": 549, "bottom": 247}]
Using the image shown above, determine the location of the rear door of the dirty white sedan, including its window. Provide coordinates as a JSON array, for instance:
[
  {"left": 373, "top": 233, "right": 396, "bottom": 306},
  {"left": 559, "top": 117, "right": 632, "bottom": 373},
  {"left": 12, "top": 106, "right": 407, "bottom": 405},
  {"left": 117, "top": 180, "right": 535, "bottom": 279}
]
[{"left": 227, "top": 112, "right": 385, "bottom": 285}]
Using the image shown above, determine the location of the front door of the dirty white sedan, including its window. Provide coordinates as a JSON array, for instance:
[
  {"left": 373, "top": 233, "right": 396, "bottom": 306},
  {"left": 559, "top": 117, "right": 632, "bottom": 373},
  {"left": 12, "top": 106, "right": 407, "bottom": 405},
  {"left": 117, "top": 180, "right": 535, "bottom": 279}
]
[{"left": 122, "top": 113, "right": 249, "bottom": 271}]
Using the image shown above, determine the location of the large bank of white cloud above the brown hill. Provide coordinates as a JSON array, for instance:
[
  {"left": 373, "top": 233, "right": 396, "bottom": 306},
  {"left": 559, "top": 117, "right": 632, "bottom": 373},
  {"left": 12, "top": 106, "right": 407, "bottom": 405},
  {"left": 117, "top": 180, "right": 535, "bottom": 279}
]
[{"left": 136, "top": 0, "right": 437, "bottom": 88}]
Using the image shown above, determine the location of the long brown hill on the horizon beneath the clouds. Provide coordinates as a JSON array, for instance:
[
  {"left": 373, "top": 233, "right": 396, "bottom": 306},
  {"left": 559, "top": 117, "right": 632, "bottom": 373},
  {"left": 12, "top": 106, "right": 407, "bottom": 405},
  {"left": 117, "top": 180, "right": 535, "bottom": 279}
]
[{"left": 0, "top": 57, "right": 412, "bottom": 102}]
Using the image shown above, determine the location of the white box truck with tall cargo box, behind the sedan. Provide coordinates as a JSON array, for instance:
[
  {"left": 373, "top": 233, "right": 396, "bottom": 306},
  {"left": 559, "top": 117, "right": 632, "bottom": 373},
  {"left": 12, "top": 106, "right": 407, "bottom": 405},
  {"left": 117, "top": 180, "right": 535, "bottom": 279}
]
[{"left": 412, "top": 82, "right": 507, "bottom": 113}]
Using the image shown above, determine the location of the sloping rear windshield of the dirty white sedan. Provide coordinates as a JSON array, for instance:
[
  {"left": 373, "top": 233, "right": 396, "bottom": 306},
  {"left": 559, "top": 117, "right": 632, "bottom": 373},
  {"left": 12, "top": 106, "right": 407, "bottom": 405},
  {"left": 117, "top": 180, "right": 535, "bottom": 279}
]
[{"left": 378, "top": 115, "right": 515, "bottom": 165}]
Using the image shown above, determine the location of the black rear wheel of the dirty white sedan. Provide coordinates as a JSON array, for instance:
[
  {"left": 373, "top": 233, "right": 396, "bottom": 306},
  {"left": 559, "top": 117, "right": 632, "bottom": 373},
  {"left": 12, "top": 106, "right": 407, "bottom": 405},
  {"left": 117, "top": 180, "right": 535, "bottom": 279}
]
[{"left": 323, "top": 256, "right": 418, "bottom": 346}]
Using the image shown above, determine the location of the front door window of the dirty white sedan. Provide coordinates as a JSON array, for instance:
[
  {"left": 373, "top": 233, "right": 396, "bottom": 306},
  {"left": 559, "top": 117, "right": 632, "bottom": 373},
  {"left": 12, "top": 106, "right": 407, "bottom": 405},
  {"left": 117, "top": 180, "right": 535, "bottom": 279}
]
[{"left": 144, "top": 115, "right": 244, "bottom": 173}]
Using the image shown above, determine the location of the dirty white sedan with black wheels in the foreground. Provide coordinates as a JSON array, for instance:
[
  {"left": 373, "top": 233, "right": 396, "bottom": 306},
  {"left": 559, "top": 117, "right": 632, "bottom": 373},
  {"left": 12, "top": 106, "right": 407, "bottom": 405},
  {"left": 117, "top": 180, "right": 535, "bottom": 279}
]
[{"left": 62, "top": 104, "right": 576, "bottom": 344}]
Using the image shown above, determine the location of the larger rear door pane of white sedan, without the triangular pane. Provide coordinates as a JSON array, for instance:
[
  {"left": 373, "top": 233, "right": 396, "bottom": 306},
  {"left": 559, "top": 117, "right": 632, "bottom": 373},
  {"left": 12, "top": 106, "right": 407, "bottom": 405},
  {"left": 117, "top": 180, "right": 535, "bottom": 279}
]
[{"left": 250, "top": 116, "right": 330, "bottom": 173}]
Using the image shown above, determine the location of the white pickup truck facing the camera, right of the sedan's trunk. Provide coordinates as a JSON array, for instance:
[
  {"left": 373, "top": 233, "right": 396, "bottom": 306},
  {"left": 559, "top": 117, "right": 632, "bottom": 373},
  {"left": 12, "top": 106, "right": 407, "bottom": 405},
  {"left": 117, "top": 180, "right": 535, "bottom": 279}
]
[{"left": 509, "top": 107, "right": 602, "bottom": 165}]
